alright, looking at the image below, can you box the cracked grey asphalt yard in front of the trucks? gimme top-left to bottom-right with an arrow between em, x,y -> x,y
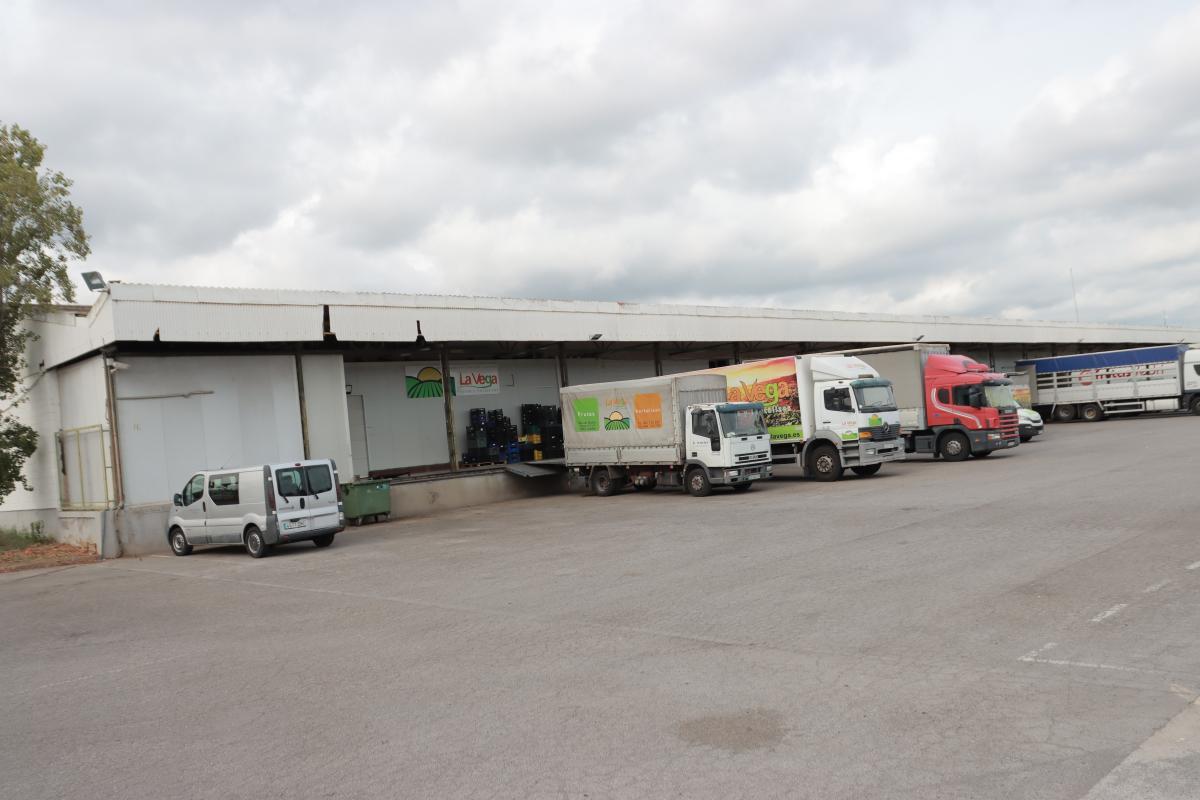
0,416 -> 1200,800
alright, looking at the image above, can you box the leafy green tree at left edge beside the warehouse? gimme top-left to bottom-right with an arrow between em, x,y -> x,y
0,124 -> 91,499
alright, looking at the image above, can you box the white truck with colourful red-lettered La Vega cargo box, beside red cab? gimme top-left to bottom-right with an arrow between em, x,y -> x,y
710,354 -> 905,481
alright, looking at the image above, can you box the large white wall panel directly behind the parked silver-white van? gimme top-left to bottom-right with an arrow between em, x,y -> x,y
115,356 -> 304,505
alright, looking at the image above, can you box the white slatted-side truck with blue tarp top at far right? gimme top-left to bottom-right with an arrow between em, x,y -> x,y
1016,344 -> 1200,422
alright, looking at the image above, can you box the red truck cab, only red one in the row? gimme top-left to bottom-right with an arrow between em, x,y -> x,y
921,354 -> 1020,461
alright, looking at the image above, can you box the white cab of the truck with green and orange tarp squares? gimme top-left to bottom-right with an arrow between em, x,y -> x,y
681,403 -> 772,497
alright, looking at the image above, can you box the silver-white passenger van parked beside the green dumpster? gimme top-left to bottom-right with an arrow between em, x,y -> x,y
167,459 -> 346,558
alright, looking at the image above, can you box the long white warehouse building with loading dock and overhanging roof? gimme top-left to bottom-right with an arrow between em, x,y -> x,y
9,282 -> 1200,557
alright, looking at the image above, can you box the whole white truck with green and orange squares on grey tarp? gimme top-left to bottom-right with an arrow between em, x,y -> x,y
562,373 -> 773,497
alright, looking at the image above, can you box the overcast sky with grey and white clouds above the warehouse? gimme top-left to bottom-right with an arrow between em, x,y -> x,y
0,0 -> 1200,325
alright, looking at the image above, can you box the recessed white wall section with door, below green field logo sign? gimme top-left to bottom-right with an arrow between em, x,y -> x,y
343,361 -> 450,475
